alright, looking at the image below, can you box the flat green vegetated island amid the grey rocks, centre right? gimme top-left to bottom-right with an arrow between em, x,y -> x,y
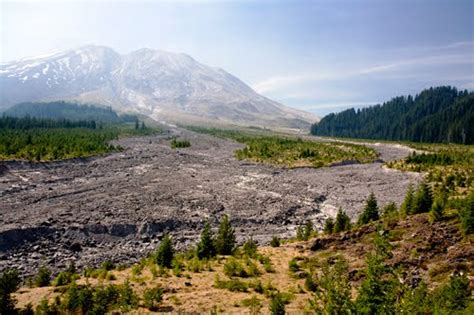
188,127 -> 377,167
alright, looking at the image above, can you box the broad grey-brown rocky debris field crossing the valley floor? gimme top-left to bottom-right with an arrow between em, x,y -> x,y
0,129 -> 420,275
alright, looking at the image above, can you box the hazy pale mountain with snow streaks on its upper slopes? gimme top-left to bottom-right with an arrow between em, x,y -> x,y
0,46 -> 317,128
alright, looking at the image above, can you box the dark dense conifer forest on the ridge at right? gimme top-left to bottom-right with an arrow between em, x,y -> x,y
311,86 -> 474,144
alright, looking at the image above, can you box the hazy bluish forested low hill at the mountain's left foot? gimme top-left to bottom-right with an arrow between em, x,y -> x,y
4,101 -> 138,123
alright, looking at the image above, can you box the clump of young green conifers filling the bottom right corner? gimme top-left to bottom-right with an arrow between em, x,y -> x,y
309,233 -> 472,314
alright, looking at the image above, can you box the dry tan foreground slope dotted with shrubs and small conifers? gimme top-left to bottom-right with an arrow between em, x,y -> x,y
7,214 -> 474,314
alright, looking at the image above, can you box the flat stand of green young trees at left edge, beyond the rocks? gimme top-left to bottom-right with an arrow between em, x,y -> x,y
0,116 -> 157,161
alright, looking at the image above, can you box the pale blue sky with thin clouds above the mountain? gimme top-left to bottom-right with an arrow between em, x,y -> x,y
0,0 -> 474,116
